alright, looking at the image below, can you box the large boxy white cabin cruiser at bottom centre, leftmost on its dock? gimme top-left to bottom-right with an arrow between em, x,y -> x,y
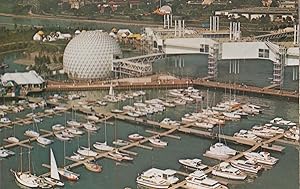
136,168 -> 179,188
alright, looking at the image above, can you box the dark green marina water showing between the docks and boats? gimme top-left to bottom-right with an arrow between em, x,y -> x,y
0,89 -> 298,189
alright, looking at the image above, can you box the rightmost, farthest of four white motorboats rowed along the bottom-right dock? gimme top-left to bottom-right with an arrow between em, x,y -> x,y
244,152 -> 278,165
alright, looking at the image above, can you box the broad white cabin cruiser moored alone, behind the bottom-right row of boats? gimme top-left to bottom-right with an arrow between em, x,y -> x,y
205,142 -> 237,160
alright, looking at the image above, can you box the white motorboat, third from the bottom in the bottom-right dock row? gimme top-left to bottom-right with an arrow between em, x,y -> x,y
230,159 -> 262,174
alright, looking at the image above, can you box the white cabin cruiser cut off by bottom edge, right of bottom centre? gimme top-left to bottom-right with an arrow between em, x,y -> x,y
185,170 -> 228,189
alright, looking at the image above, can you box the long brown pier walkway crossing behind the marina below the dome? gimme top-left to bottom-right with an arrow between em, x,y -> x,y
46,78 -> 299,100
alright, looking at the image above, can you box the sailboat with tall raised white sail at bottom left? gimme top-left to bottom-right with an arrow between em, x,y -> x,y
44,148 -> 64,186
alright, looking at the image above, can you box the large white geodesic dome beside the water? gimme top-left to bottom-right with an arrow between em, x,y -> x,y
63,30 -> 122,79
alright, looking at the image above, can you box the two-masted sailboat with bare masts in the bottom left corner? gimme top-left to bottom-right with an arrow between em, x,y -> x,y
10,148 -> 39,188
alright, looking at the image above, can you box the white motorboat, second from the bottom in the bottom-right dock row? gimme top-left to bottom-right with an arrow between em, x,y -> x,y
212,162 -> 247,180
